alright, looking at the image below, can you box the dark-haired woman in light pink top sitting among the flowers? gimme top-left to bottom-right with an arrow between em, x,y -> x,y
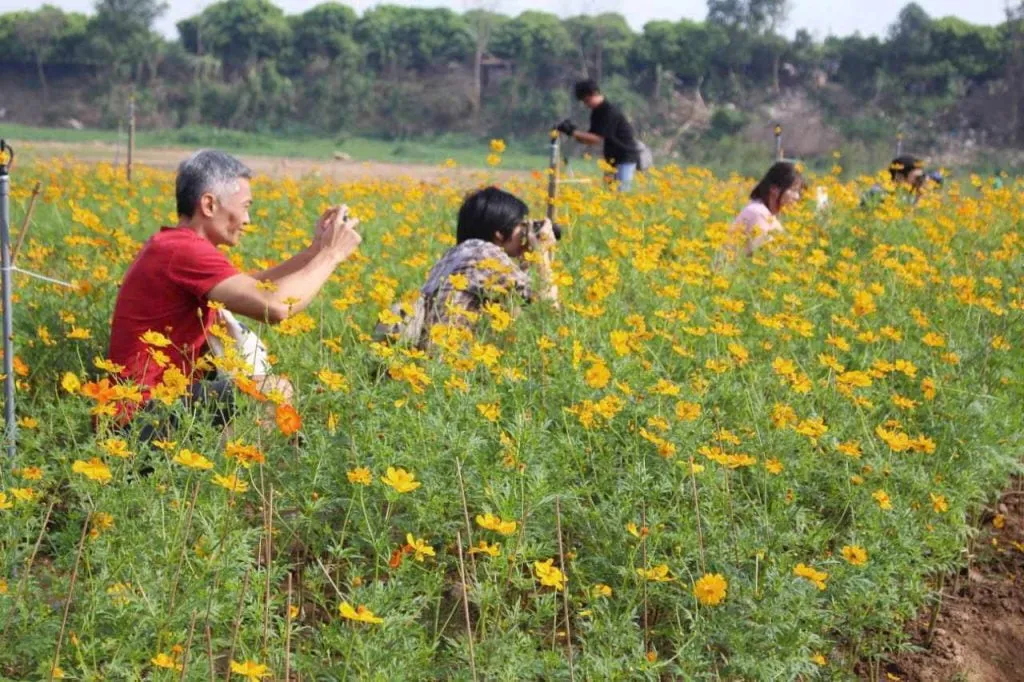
730,161 -> 804,256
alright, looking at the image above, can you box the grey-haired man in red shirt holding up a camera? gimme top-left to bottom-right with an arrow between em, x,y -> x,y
108,150 -> 360,430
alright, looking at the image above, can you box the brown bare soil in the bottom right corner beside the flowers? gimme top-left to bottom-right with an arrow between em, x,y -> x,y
868,480 -> 1024,682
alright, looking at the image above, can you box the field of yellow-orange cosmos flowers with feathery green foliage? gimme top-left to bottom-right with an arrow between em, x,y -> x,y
0,156 -> 1024,680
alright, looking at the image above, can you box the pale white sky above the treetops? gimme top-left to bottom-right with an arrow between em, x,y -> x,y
0,0 -> 1006,38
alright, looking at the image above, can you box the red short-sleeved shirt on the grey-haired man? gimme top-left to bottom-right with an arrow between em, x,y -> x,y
108,227 -> 239,417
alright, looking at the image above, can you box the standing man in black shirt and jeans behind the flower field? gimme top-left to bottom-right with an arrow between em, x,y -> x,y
555,80 -> 640,190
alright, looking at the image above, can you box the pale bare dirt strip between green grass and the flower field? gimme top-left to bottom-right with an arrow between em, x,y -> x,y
17,142 -> 530,184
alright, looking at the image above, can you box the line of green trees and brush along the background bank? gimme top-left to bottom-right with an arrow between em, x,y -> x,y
0,0 -> 1024,148
